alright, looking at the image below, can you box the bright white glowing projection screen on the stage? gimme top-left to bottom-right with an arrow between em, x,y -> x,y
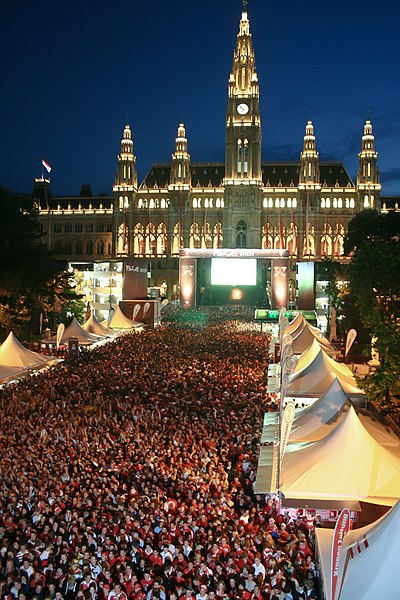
211,258 -> 257,286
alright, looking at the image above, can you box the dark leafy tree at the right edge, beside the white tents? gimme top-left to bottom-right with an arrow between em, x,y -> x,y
345,210 -> 400,400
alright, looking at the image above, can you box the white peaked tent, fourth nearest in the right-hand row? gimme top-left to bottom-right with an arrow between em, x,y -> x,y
286,340 -> 364,399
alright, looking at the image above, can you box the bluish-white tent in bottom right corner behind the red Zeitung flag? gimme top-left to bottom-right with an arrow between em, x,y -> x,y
315,502 -> 400,600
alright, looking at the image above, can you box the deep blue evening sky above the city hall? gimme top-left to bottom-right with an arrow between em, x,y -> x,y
0,0 -> 400,194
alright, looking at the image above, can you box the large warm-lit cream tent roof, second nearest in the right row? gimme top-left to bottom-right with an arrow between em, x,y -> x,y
281,406 -> 400,506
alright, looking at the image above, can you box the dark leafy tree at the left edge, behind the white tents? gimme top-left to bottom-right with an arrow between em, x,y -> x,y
0,187 -> 83,337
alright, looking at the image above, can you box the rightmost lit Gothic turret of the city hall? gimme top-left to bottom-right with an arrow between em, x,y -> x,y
357,119 -> 382,208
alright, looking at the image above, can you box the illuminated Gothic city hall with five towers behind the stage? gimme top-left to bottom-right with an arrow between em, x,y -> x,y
34,2 -> 394,312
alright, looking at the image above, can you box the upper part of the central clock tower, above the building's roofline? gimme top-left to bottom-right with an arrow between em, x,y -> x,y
225,2 -> 261,184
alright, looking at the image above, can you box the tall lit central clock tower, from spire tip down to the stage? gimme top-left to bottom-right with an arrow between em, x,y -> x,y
224,1 -> 262,248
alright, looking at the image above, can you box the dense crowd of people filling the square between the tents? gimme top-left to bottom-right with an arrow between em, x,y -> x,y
0,318 -> 318,600
